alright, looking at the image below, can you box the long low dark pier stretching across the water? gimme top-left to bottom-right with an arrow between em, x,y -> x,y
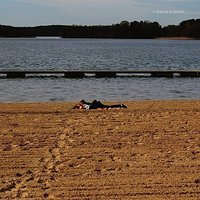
0,70 -> 200,78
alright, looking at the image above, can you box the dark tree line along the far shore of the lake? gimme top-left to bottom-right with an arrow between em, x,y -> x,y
0,19 -> 200,39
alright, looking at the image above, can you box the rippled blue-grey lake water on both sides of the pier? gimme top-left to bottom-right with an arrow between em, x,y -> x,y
0,38 -> 200,102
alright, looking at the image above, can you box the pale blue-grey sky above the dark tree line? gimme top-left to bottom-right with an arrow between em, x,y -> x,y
0,0 -> 200,26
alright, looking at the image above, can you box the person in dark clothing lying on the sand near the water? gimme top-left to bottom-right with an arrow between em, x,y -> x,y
73,100 -> 127,110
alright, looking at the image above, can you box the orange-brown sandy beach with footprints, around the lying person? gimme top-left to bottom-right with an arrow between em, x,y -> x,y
0,101 -> 200,200
